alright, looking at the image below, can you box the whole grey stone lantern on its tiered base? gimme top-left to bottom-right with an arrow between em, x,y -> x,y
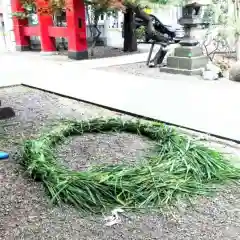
160,0 -> 210,75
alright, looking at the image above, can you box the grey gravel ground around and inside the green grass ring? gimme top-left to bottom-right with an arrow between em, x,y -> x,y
0,87 -> 240,240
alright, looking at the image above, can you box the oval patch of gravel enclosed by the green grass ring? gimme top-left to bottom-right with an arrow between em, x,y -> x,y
57,133 -> 151,170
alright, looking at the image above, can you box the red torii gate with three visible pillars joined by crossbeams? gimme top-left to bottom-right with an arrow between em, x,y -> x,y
11,0 -> 88,60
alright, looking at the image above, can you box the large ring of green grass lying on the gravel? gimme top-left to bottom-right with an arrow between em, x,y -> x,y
21,118 -> 240,212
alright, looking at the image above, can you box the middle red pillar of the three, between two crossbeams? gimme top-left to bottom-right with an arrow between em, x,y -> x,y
36,0 -> 56,52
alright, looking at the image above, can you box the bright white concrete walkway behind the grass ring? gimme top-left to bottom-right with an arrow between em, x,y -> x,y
0,52 -> 240,141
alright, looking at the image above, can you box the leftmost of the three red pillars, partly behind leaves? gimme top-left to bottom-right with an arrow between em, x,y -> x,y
11,0 -> 30,51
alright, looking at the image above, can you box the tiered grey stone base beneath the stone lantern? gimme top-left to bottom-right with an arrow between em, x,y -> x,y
160,46 -> 208,75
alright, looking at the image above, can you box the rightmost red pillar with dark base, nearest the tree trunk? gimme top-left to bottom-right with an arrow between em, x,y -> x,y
66,0 -> 88,60
